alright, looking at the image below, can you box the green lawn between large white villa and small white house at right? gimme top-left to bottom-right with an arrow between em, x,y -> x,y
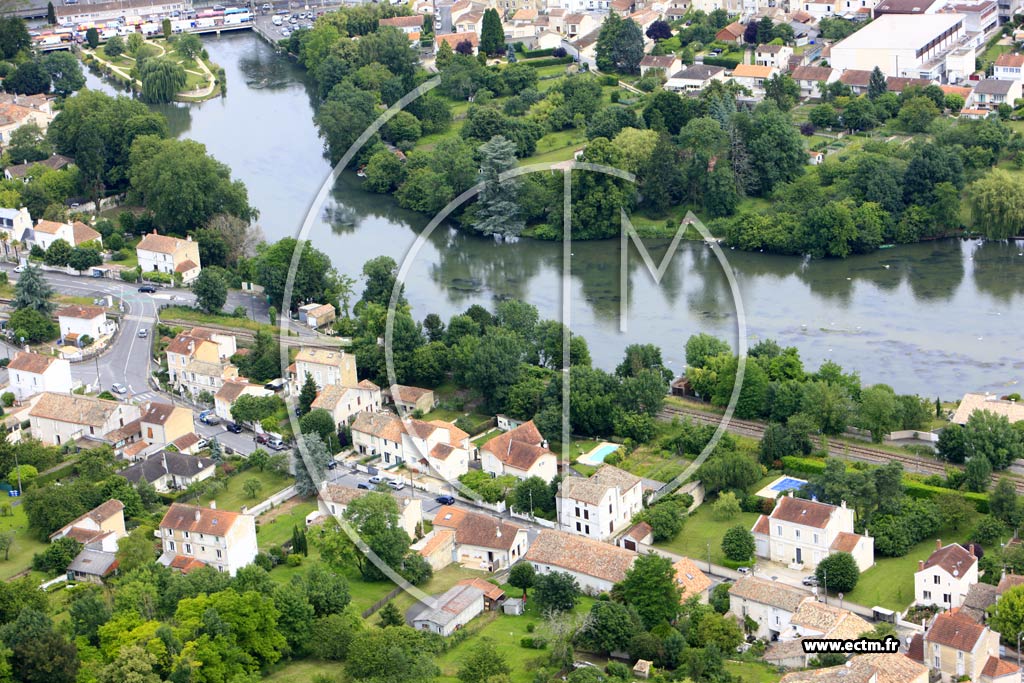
843,516 -> 976,610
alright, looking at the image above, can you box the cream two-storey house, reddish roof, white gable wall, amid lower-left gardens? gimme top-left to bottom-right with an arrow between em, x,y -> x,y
157,503 -> 259,577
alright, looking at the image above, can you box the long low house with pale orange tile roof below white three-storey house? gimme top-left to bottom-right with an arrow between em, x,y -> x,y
524,529 -> 637,595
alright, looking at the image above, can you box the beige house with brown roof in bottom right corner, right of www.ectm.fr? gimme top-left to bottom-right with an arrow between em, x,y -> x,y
908,611 -> 1020,683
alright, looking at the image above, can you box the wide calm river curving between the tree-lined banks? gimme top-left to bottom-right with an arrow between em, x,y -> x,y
83,32 -> 1024,399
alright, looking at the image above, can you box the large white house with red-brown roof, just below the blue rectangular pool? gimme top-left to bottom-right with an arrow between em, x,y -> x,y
751,492 -> 874,571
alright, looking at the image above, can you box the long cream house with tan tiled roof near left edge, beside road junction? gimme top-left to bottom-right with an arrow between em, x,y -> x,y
29,392 -> 139,445
